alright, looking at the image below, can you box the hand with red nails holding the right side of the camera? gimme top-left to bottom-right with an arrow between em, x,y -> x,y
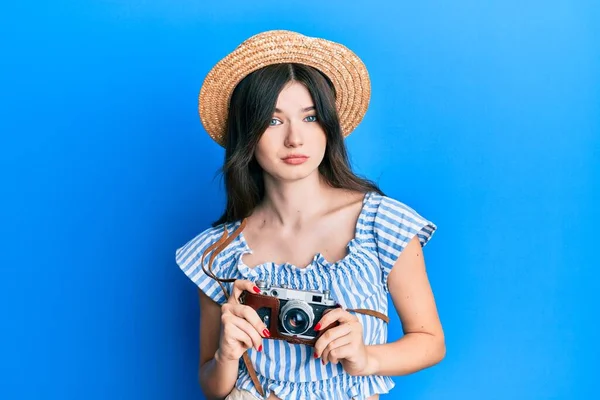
315,308 -> 369,376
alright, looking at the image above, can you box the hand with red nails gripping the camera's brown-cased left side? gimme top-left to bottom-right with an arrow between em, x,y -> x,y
215,280 -> 271,362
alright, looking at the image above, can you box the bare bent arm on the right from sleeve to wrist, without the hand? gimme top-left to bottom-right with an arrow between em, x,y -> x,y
361,236 -> 446,376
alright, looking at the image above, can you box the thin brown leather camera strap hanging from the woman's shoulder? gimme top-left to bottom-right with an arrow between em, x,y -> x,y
200,218 -> 390,396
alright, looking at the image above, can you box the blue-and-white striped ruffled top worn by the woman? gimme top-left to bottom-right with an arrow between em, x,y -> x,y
176,192 -> 436,400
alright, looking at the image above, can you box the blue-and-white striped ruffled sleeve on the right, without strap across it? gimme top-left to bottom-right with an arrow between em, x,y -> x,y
373,197 -> 437,291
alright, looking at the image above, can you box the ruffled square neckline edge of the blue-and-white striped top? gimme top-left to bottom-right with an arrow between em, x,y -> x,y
236,191 -> 374,271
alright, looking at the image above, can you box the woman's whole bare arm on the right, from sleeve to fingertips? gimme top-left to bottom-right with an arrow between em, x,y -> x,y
315,236 -> 446,376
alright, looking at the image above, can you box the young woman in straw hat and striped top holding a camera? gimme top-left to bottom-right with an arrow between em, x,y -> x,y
176,31 -> 445,399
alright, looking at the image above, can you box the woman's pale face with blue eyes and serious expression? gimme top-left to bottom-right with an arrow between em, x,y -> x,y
255,82 -> 326,181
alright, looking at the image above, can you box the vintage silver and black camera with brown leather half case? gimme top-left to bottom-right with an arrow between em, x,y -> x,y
241,281 -> 339,344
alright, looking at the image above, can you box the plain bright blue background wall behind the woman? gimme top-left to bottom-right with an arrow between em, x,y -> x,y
0,0 -> 600,400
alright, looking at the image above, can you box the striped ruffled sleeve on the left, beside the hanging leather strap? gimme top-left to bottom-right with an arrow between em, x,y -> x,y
175,226 -> 231,304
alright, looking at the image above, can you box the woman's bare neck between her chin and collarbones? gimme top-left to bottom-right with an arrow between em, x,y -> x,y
259,173 -> 333,228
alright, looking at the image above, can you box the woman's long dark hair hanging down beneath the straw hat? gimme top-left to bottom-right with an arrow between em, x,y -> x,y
213,63 -> 383,226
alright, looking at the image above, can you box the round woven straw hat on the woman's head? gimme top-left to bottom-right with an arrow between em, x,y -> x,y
198,30 -> 371,146
